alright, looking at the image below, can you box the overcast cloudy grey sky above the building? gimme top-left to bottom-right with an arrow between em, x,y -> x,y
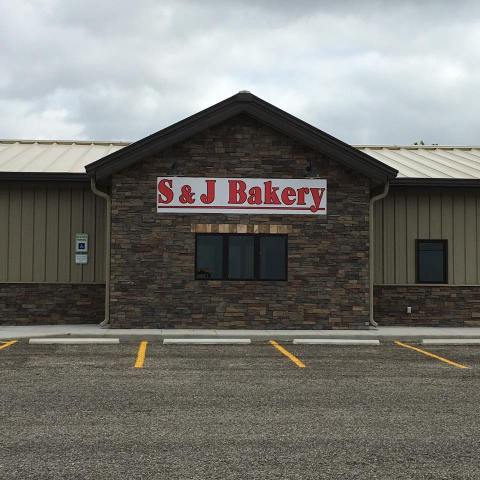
0,0 -> 480,145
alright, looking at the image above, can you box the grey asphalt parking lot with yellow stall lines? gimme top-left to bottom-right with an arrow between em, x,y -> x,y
0,341 -> 480,479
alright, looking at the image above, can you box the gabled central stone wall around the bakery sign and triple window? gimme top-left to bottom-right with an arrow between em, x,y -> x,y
111,115 -> 369,329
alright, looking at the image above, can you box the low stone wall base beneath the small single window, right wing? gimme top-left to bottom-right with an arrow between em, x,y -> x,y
374,285 -> 480,327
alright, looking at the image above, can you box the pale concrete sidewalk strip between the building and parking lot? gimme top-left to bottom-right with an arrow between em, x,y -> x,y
0,325 -> 480,341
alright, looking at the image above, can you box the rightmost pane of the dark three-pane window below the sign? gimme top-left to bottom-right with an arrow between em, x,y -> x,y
259,235 -> 287,280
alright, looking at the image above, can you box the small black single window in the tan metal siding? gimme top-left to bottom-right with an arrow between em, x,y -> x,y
416,240 -> 448,283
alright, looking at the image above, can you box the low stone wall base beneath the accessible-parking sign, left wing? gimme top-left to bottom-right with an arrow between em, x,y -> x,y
0,283 -> 105,325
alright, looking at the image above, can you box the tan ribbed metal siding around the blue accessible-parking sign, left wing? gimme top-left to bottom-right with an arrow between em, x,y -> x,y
0,182 -> 105,283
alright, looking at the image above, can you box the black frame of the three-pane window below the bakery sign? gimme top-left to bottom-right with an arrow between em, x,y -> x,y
193,232 -> 288,282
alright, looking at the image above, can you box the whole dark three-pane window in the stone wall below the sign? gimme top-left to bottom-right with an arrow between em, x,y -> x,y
195,233 -> 288,280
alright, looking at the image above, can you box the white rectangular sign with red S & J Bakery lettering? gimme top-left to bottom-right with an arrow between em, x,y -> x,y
157,177 -> 327,215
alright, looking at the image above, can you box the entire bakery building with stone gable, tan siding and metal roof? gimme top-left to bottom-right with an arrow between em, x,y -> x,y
0,92 -> 480,329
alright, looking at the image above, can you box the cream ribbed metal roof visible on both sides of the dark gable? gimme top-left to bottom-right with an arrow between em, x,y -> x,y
0,140 -> 480,179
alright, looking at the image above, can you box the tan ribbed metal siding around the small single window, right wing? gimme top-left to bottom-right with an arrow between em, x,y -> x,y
374,189 -> 480,285
